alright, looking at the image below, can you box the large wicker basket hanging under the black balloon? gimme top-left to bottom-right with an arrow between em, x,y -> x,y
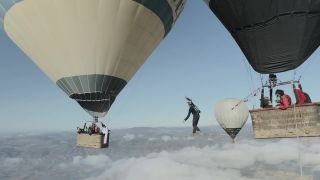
250,103 -> 320,138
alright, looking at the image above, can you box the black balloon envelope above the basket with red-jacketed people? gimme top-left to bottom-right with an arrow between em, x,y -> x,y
209,0 -> 320,73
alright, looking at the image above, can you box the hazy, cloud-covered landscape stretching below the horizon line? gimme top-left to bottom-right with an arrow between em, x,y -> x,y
0,126 -> 320,180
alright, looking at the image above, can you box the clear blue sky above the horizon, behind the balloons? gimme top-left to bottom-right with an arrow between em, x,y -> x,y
0,1 -> 320,131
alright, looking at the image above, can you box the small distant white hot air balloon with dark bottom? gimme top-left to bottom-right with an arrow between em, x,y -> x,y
214,98 -> 249,142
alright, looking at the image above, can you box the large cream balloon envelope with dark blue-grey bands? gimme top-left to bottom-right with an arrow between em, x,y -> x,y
0,0 -> 185,117
